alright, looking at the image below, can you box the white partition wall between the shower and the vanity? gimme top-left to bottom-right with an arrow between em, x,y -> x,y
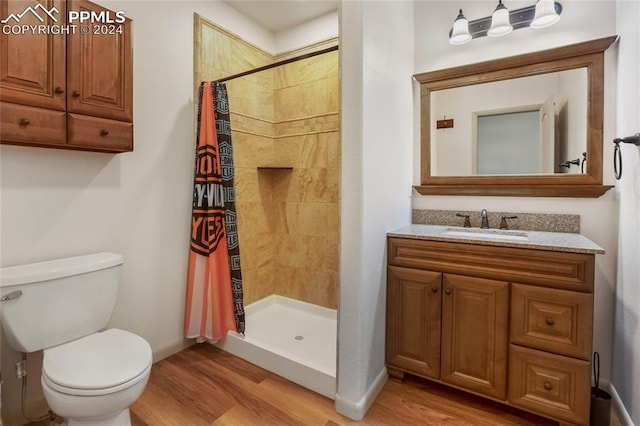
336,0 -> 413,419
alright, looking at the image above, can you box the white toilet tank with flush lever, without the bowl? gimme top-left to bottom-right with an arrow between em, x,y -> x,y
0,253 -> 122,352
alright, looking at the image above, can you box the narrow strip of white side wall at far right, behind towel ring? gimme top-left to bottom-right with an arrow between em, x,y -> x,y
612,1 -> 640,425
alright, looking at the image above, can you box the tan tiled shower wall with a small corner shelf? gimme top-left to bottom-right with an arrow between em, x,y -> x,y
195,19 -> 340,309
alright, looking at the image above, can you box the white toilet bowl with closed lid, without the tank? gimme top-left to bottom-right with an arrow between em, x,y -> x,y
41,328 -> 152,426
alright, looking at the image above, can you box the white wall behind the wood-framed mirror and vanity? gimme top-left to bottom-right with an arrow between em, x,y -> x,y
413,0 -> 624,390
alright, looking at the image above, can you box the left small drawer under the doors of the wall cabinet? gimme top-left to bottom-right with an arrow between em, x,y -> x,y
0,102 -> 67,145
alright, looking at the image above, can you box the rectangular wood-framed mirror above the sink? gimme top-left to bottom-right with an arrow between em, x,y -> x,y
414,36 -> 617,198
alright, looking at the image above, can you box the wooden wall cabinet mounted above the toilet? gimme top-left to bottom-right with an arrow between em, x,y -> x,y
0,0 -> 133,152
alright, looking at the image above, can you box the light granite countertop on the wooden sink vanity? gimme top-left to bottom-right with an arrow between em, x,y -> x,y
387,224 -> 604,254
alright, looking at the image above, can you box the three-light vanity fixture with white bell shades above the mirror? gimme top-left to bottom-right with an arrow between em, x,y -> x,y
449,0 -> 562,45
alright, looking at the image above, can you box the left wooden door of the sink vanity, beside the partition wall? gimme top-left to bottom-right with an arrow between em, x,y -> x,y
386,266 -> 442,379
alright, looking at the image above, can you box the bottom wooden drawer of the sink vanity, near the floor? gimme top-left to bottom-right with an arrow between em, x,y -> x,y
509,345 -> 591,425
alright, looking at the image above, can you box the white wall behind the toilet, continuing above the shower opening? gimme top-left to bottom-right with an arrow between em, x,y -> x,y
0,1 -> 273,420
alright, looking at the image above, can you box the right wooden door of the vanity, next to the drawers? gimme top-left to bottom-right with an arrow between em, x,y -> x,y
441,274 -> 509,400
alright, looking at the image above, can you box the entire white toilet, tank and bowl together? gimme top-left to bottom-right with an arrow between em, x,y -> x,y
0,253 -> 152,426
